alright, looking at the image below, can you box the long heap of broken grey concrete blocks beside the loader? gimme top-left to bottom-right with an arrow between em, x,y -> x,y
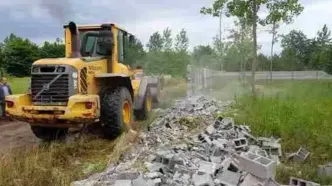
74,96 -> 320,186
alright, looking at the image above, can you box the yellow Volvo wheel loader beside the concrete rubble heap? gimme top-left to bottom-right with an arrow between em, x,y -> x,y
6,22 -> 159,140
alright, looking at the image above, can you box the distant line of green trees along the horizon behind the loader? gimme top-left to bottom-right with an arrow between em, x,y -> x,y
0,23 -> 332,76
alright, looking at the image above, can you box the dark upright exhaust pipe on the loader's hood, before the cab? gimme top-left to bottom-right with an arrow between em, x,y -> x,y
68,21 -> 81,58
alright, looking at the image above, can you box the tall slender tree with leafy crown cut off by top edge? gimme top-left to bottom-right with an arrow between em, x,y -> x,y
201,0 -> 303,95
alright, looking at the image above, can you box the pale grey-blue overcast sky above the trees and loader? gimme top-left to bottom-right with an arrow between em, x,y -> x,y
0,0 -> 332,54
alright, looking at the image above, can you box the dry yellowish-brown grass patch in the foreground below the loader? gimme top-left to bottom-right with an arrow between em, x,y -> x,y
0,136 -> 117,186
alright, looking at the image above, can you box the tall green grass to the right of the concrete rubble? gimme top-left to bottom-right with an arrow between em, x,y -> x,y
227,81 -> 332,184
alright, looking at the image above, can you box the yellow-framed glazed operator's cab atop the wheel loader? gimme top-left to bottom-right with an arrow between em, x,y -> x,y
64,22 -> 135,64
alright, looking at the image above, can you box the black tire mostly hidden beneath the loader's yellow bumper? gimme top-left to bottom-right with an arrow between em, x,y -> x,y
30,126 -> 68,141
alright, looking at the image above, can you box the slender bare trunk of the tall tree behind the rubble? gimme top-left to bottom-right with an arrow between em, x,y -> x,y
251,0 -> 257,97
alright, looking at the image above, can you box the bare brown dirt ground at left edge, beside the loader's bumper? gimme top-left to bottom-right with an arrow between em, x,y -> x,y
0,120 -> 36,152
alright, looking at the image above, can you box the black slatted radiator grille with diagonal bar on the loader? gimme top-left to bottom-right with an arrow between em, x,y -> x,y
31,74 -> 69,105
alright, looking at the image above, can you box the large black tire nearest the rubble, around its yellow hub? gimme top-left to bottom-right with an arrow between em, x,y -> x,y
100,87 -> 133,139
